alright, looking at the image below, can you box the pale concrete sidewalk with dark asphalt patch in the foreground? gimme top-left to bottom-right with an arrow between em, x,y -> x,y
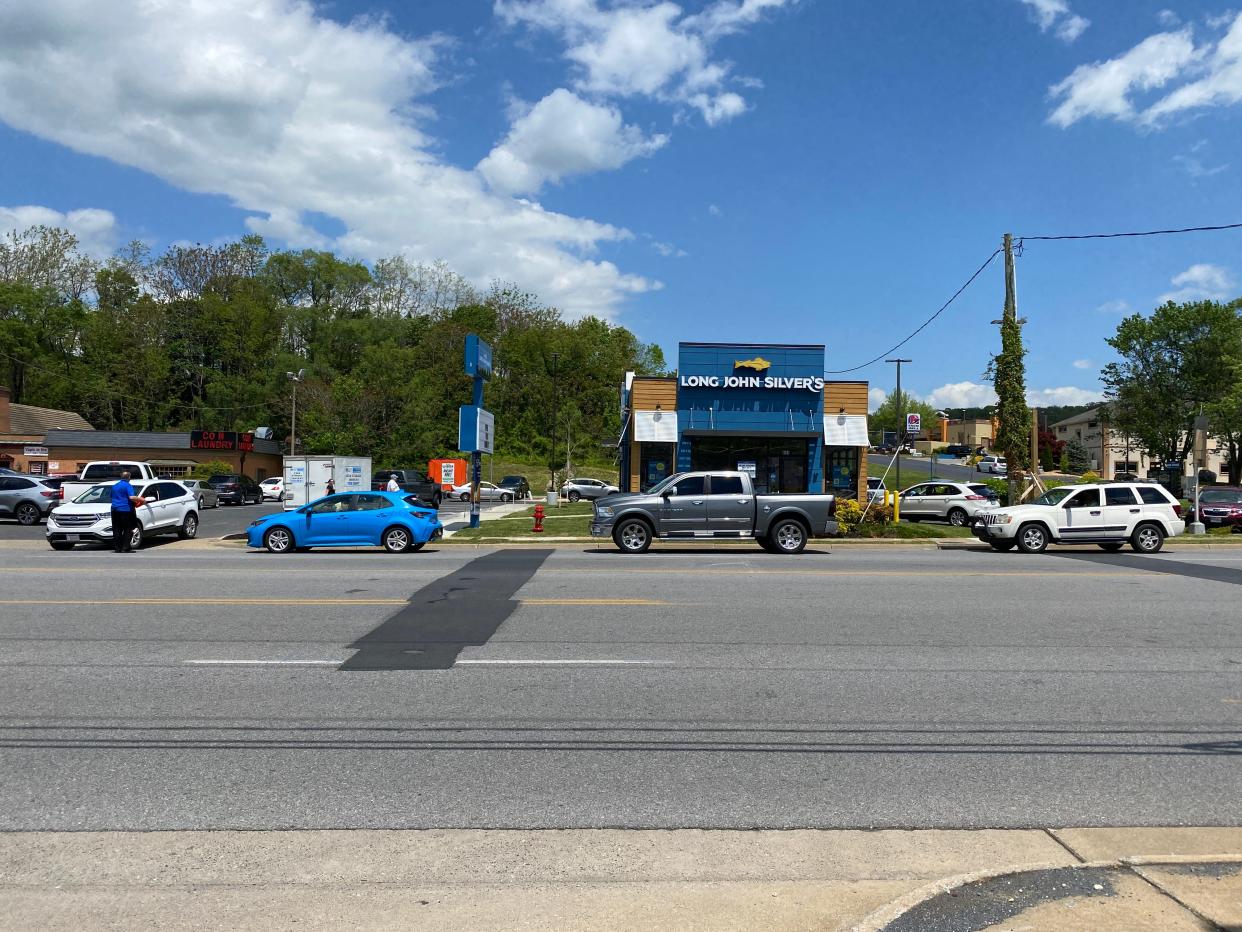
0,828 -> 1242,932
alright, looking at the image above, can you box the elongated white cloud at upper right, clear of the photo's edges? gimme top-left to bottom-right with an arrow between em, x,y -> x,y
1048,29 -> 1199,127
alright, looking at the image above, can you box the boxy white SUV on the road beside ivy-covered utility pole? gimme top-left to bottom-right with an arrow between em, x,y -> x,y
974,482 -> 1186,553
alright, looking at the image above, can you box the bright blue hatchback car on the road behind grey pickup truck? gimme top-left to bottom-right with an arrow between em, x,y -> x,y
246,492 -> 443,553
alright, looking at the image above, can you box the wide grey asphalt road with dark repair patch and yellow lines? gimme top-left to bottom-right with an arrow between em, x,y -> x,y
0,536 -> 1242,830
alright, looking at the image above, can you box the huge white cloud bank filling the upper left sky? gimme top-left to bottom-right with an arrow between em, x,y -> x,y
0,0 -> 658,316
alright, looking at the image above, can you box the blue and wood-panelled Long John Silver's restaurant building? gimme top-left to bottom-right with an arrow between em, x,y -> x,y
620,343 -> 867,498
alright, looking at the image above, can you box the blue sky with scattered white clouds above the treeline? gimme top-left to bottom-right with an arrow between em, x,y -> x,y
0,0 -> 1242,406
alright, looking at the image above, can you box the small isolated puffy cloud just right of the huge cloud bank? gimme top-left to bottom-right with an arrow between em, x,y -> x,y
478,87 -> 668,194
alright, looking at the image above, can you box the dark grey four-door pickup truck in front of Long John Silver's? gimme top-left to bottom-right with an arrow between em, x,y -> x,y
591,472 -> 838,553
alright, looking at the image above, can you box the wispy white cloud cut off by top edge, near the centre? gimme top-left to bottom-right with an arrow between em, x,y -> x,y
496,0 -> 792,124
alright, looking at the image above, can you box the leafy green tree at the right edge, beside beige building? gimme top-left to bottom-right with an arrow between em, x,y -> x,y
1100,301 -> 1242,461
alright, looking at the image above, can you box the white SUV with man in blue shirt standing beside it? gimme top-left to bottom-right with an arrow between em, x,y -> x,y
46,480 -> 199,551
